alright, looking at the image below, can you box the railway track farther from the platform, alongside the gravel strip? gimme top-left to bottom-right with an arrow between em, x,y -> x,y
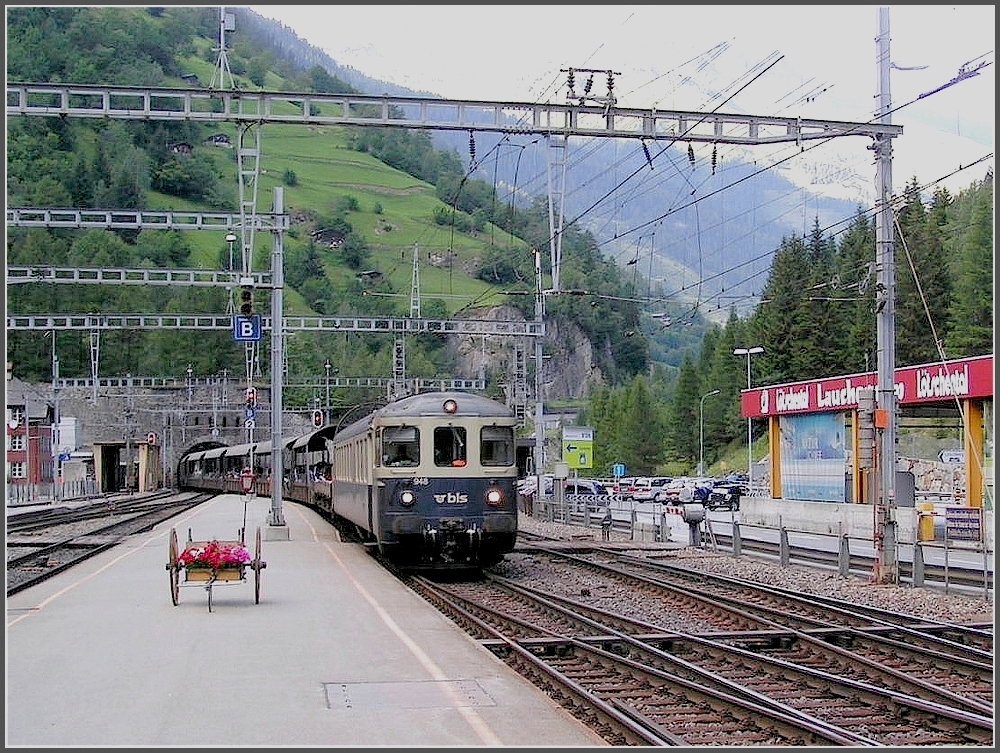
504,552 -> 993,713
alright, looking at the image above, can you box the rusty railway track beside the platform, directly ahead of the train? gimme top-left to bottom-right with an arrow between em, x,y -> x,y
409,577 -> 993,745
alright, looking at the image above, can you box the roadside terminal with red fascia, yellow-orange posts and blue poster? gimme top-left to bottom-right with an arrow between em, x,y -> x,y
741,354 -> 994,509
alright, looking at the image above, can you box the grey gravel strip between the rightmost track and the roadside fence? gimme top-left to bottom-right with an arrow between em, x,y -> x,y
518,513 -> 995,624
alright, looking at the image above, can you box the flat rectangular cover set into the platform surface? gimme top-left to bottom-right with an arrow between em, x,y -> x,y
323,680 -> 496,709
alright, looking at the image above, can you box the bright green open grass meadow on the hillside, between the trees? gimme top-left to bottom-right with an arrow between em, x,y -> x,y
149,45 -> 530,315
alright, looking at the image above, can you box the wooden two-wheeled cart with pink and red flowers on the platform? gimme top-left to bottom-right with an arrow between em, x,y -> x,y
167,526 -> 267,612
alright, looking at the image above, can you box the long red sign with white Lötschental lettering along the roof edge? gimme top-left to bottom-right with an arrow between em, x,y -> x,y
740,355 -> 993,418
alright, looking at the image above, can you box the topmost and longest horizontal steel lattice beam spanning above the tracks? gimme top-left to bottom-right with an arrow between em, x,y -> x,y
7,82 -> 903,146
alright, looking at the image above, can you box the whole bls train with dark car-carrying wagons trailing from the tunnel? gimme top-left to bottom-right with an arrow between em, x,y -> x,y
177,391 -> 520,569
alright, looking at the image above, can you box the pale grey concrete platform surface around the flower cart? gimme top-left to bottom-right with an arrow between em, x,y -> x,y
5,495 -> 606,748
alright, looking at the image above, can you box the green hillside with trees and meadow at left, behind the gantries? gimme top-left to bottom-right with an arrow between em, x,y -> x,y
7,8 -> 648,396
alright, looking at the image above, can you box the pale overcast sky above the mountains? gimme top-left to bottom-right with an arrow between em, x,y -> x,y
248,4 -> 996,197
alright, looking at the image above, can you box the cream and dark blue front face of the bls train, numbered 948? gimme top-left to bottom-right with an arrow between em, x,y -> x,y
377,396 -> 517,567
